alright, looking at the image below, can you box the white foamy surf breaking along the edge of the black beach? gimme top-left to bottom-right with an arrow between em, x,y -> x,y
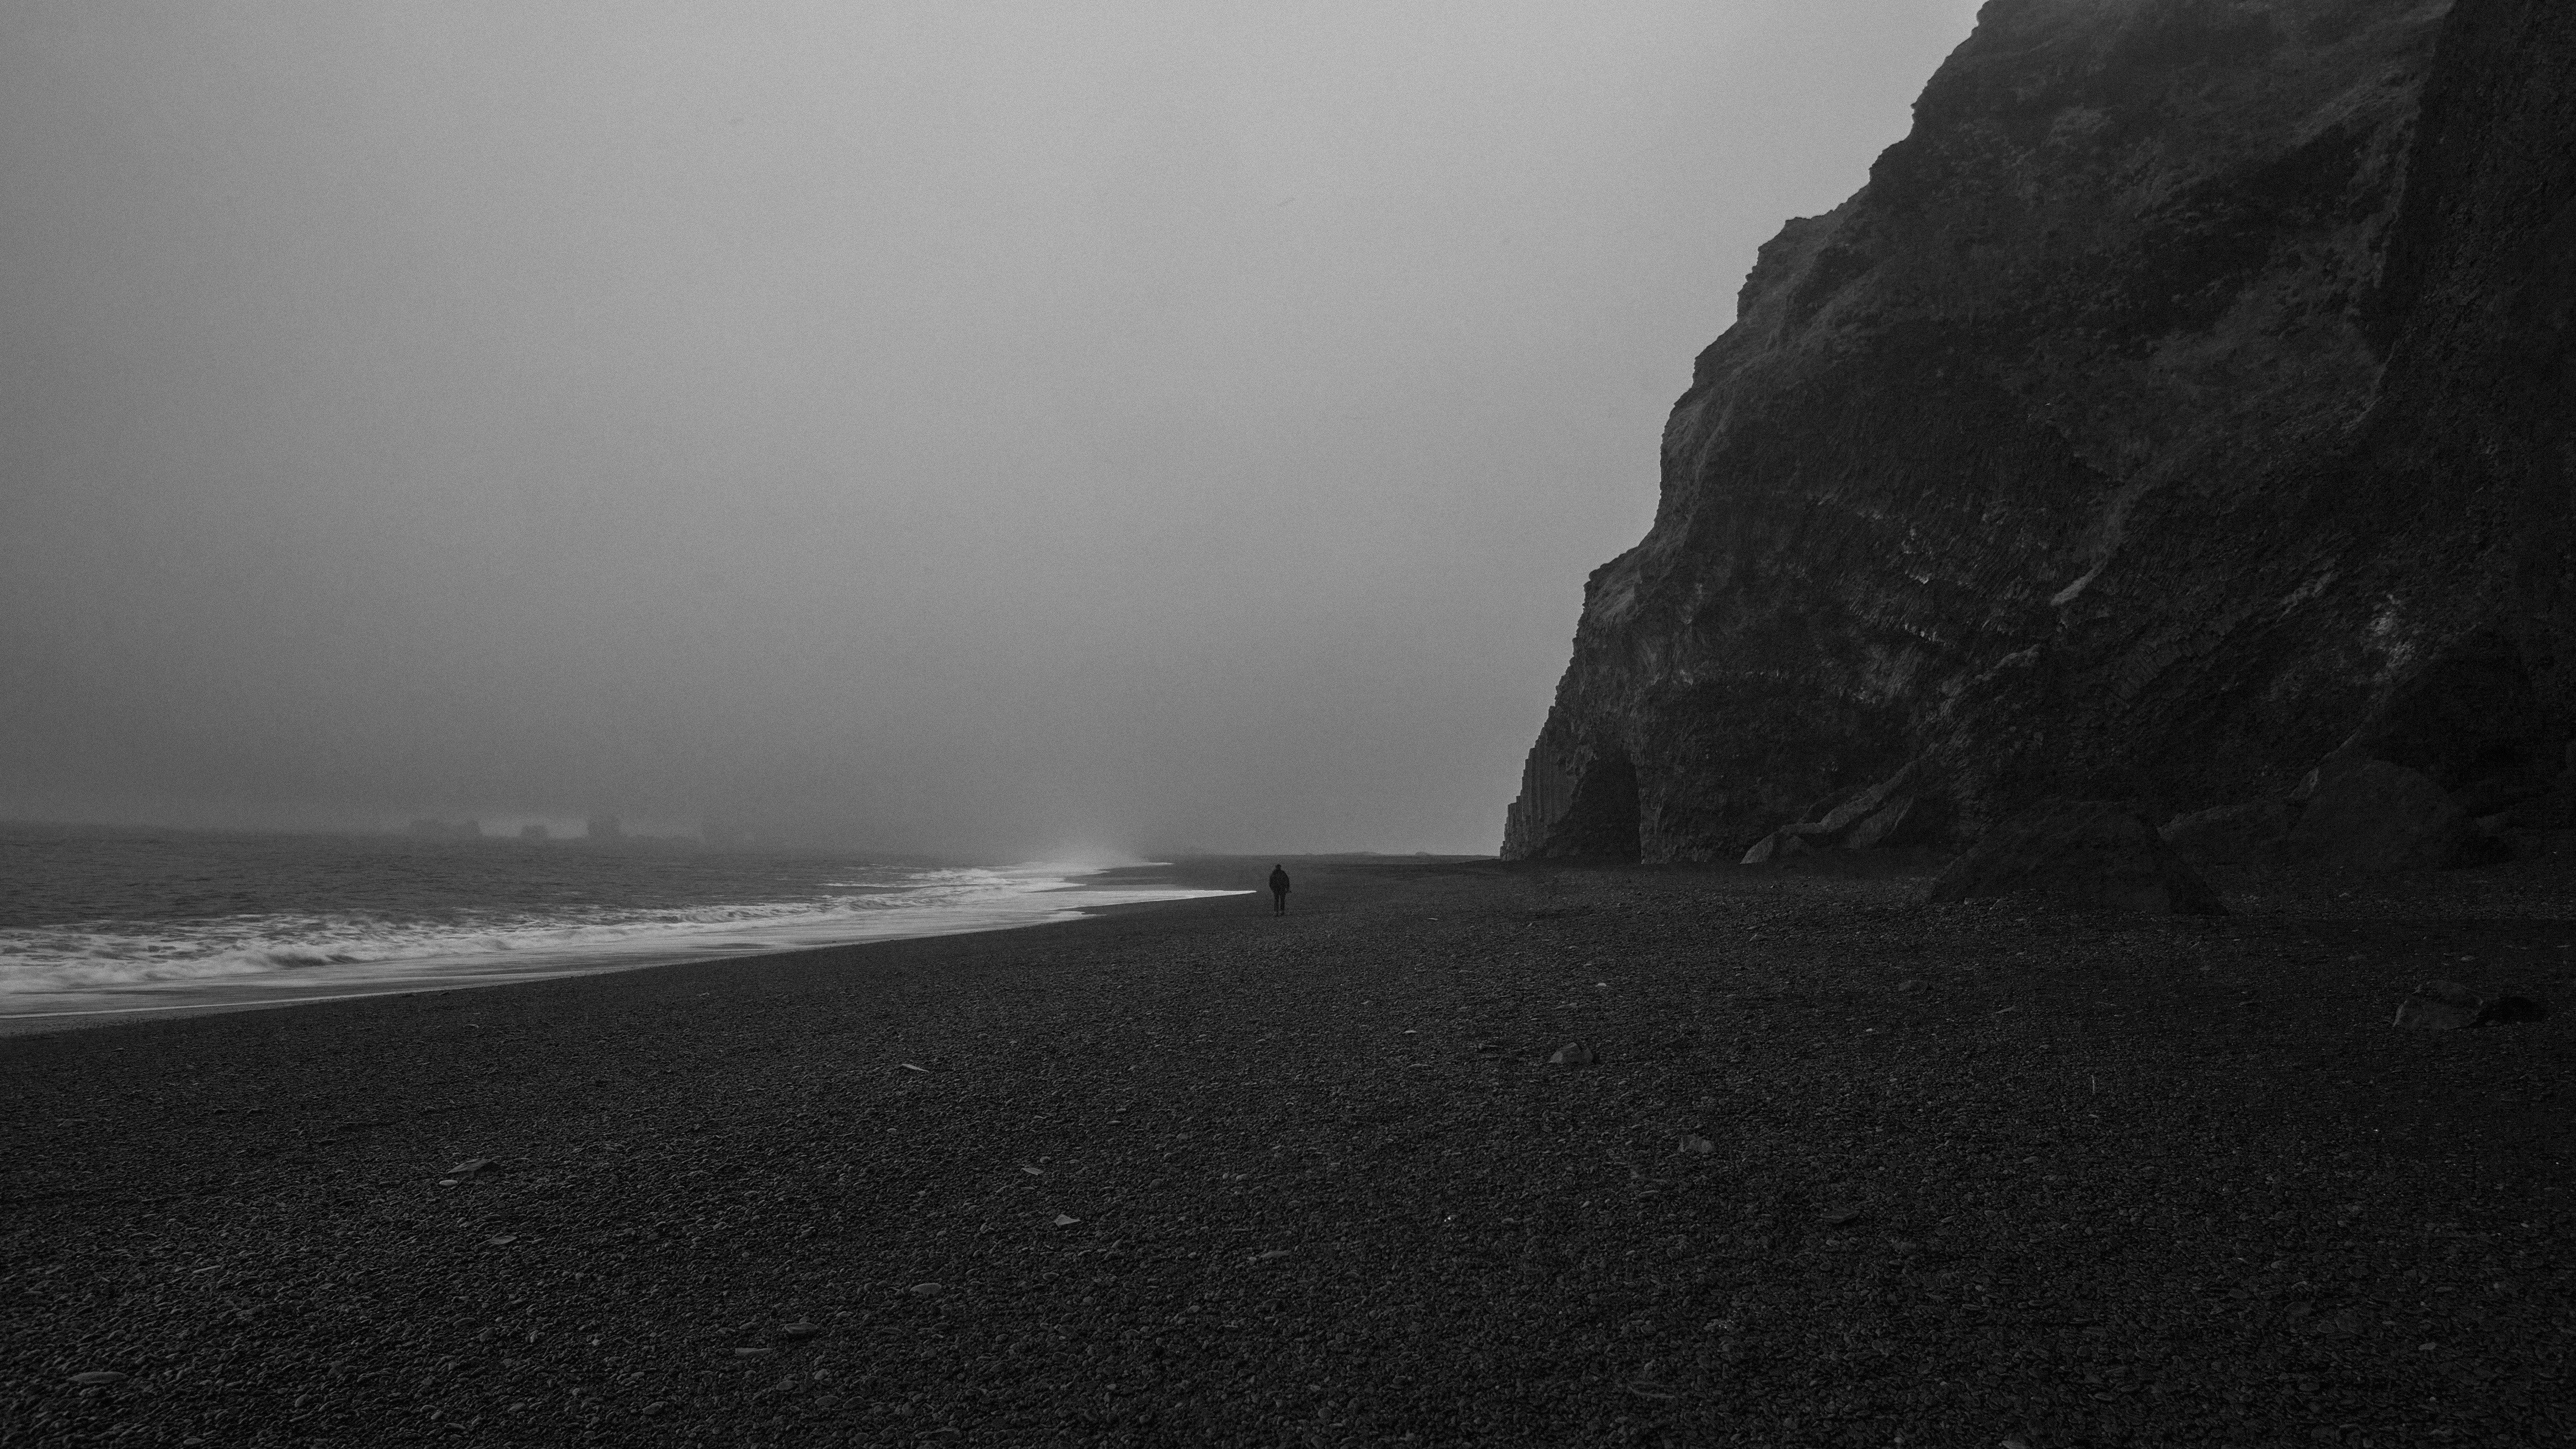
0,862 -> 1211,1004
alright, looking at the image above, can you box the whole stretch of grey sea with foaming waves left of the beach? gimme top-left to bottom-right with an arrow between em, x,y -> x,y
0,826 -> 1236,1022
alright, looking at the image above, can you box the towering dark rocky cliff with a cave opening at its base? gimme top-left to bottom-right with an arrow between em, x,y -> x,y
1504,0 -> 2576,860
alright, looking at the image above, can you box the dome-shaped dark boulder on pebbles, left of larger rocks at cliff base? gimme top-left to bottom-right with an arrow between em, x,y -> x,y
1927,801 -> 2225,916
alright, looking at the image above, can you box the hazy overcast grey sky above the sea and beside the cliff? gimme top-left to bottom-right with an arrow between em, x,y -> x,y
0,0 -> 1973,857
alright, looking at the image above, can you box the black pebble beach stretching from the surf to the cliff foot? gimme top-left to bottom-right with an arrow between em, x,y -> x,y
0,860 -> 2576,1449
